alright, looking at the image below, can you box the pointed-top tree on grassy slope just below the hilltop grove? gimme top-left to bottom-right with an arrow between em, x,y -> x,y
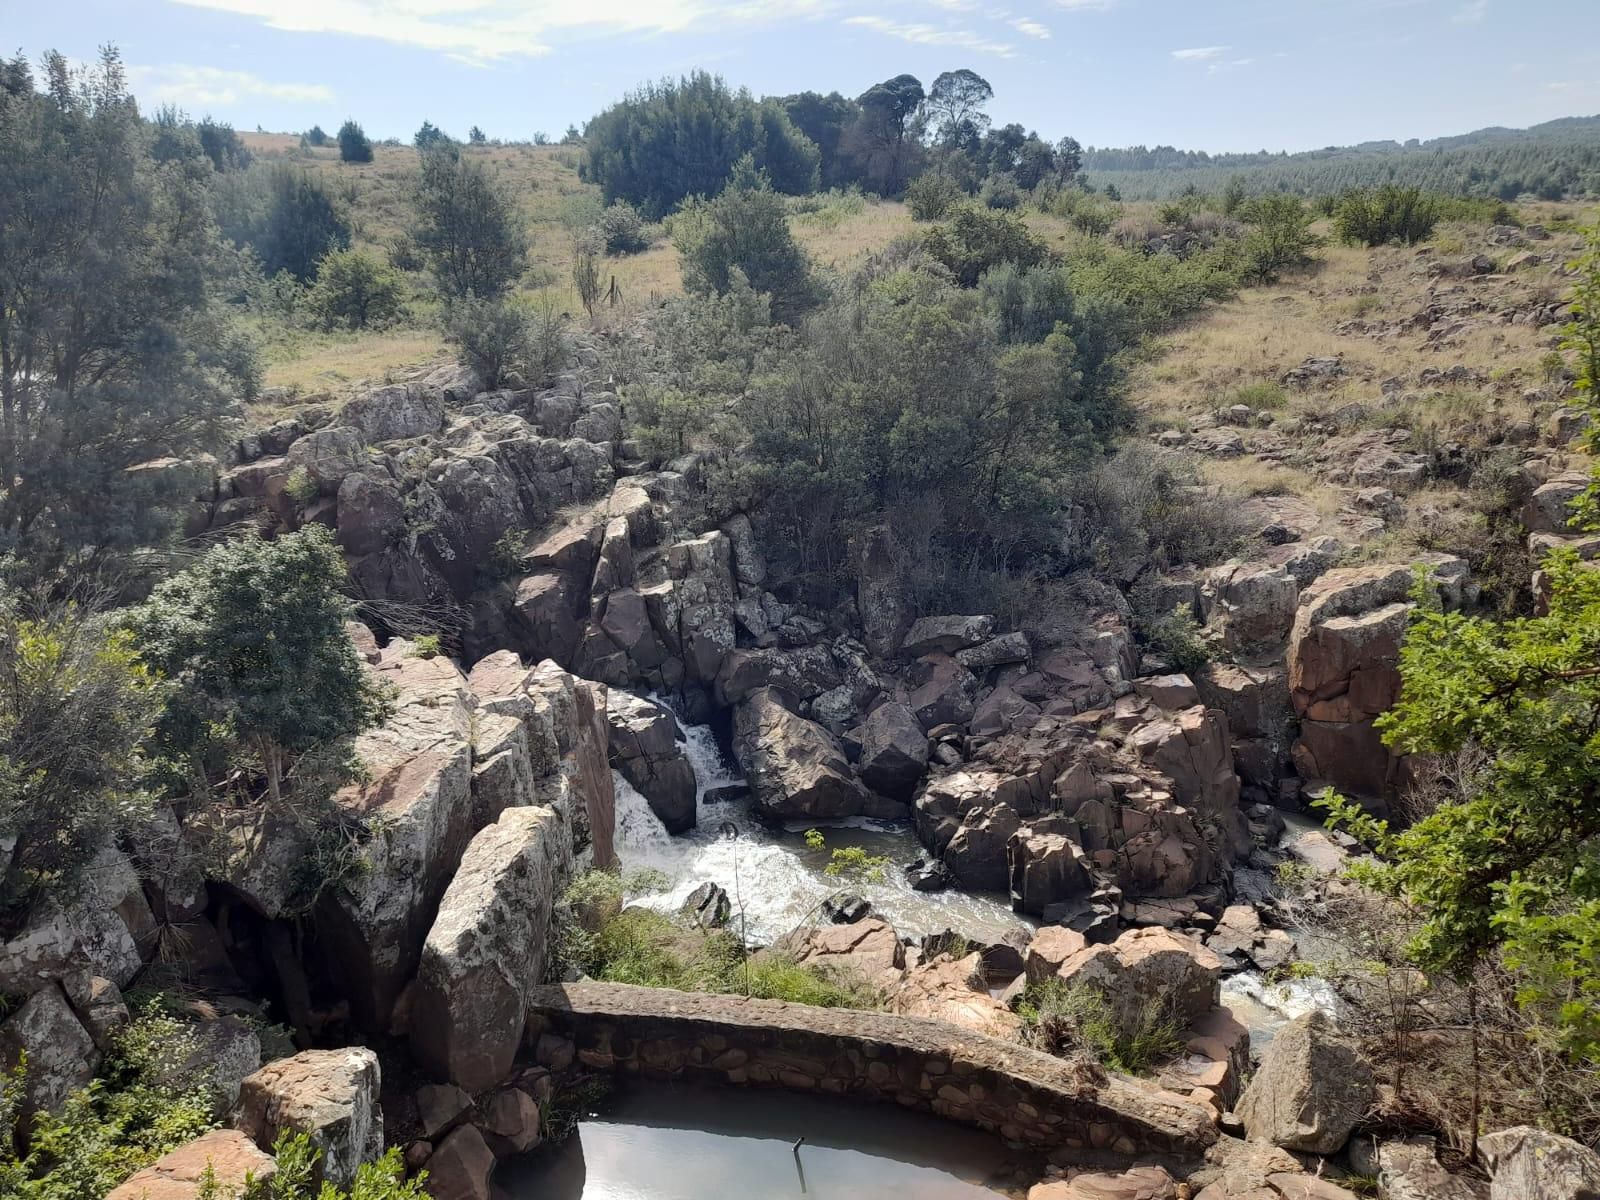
672,158 -> 816,322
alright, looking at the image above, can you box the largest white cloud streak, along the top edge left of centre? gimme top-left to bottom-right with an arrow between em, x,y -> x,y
173,0 -> 835,66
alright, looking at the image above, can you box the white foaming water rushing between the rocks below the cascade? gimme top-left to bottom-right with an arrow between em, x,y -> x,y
613,698 -> 1024,944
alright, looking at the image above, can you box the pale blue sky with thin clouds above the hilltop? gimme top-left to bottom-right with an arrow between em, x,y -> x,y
12,0 -> 1600,150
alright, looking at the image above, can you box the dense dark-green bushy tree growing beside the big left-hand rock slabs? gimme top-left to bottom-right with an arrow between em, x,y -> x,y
128,525 -> 389,806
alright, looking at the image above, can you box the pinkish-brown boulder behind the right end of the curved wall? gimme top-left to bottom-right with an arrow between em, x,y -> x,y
1056,926 -> 1222,1030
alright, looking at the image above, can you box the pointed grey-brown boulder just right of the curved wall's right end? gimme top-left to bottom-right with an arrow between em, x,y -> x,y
1238,1010 -> 1374,1154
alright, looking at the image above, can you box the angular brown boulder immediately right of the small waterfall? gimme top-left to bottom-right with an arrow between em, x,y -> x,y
733,688 -> 866,821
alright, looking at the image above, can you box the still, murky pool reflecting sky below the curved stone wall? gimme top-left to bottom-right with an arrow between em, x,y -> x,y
494,1083 -> 1037,1200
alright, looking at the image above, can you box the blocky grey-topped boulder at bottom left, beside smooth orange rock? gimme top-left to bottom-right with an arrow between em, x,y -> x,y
234,1046 -> 384,1187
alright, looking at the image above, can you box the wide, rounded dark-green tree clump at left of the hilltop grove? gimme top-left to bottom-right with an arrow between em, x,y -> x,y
584,72 -> 819,218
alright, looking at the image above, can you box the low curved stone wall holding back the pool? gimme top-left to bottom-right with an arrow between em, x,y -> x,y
528,982 -> 1216,1163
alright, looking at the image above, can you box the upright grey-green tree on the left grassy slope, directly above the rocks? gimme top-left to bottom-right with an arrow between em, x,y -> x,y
416,144 -> 528,299
